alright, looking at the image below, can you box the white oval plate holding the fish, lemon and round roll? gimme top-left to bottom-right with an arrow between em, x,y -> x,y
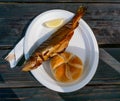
24,9 -> 99,92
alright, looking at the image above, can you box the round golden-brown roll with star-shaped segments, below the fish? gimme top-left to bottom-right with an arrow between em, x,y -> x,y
50,52 -> 83,83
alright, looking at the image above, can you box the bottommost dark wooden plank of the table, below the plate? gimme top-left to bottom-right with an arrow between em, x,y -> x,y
0,85 -> 120,101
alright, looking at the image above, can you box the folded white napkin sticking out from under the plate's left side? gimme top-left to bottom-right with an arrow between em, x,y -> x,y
5,37 -> 24,68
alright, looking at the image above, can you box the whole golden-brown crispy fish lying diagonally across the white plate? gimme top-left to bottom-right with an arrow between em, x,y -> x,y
22,7 -> 86,71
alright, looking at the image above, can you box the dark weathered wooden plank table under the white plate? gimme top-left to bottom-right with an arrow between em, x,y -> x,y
0,0 -> 120,101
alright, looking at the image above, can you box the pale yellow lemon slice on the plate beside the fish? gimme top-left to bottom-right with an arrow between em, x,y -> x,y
44,18 -> 63,28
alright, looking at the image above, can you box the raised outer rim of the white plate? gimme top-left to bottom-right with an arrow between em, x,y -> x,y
24,9 -> 99,93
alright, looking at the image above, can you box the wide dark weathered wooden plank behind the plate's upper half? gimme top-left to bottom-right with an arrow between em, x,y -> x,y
0,3 -> 120,47
